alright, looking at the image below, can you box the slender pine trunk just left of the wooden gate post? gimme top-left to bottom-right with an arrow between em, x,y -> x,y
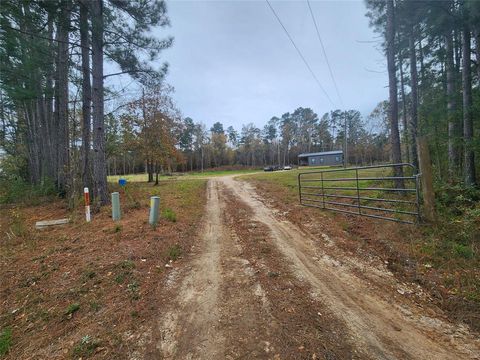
408,25 -> 418,170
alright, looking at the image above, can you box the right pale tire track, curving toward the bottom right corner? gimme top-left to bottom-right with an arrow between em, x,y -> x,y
224,177 -> 480,359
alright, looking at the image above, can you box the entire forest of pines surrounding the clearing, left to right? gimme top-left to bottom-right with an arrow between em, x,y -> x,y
0,0 -> 480,205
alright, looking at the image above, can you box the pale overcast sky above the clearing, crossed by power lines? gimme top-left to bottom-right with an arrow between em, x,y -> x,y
114,1 -> 388,129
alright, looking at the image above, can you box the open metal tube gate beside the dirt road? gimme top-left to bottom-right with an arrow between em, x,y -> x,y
298,163 -> 420,224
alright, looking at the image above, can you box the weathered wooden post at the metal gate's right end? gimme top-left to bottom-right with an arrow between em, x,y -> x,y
417,136 -> 436,222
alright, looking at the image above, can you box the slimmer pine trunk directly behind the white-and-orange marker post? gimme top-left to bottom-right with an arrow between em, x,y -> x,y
80,2 -> 92,188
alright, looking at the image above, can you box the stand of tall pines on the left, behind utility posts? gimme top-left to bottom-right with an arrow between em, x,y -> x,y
0,0 -> 173,205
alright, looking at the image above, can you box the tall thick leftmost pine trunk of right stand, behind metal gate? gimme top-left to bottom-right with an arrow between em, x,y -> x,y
385,0 -> 404,188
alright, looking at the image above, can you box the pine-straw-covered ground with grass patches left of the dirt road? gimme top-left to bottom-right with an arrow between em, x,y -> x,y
0,179 -> 206,359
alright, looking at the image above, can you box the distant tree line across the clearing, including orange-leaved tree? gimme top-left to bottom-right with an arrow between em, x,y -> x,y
107,102 -> 390,181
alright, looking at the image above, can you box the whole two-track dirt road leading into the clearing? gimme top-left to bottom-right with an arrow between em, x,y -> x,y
154,177 -> 480,359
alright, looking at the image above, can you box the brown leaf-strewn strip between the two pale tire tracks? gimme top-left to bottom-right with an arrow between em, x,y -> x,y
222,189 -> 360,360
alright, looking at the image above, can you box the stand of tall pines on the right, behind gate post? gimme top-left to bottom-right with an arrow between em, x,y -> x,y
366,0 -> 480,187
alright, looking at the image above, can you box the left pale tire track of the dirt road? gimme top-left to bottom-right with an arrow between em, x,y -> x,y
157,182 -> 224,359
